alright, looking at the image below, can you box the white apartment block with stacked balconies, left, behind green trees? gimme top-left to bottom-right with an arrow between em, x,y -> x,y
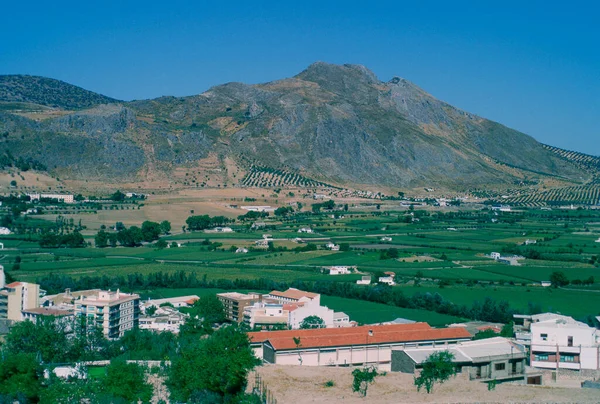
75,290 -> 140,339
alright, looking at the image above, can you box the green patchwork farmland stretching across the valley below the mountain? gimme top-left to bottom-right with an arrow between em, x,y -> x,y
0,196 -> 600,324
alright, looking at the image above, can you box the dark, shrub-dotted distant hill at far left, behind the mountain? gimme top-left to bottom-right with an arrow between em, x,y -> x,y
0,75 -> 117,110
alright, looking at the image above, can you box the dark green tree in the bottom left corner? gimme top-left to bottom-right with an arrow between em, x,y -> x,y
0,353 -> 44,403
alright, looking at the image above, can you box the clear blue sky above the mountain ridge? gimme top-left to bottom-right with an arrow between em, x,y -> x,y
0,0 -> 600,155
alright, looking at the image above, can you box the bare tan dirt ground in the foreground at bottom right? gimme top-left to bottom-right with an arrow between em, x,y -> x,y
256,365 -> 600,404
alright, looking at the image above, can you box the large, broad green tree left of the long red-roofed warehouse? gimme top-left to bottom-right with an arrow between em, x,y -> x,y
167,326 -> 259,402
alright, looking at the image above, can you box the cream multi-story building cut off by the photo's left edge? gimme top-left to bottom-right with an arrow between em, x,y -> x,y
0,280 -> 40,321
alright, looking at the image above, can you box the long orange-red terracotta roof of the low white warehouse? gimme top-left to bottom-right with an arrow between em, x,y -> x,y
248,323 -> 471,350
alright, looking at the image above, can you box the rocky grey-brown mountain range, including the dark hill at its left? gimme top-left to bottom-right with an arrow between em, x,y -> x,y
0,62 -> 589,189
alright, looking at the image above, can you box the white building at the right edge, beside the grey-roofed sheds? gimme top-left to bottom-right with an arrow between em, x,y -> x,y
526,313 -> 600,370
